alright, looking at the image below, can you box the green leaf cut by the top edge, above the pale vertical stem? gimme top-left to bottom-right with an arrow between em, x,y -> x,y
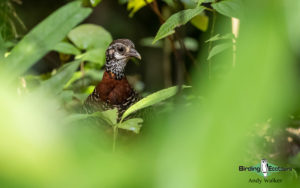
212,0 -> 242,18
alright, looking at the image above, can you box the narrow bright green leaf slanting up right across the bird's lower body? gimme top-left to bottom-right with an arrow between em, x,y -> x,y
121,86 -> 190,122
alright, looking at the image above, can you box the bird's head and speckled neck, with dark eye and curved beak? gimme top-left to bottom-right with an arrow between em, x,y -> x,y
105,39 -> 141,79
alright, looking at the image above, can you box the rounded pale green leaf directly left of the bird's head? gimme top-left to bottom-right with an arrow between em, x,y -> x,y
68,24 -> 112,50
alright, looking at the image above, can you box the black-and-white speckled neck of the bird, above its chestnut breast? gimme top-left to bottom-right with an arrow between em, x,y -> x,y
105,59 -> 127,80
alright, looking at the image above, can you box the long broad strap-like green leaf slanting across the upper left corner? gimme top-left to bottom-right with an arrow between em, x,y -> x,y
0,1 -> 91,81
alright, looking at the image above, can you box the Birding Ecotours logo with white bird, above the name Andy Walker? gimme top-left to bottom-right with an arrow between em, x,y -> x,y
239,159 -> 293,178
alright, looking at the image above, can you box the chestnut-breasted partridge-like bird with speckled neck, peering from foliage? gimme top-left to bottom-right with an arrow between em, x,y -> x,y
83,39 -> 141,121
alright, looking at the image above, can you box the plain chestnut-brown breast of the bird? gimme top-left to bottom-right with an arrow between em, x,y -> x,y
96,71 -> 133,105
